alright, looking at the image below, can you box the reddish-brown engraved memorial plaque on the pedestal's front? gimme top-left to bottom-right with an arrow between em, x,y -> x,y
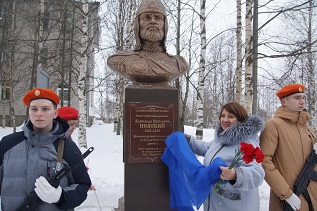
127,103 -> 177,163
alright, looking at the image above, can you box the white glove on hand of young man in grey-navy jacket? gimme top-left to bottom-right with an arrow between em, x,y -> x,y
34,176 -> 62,204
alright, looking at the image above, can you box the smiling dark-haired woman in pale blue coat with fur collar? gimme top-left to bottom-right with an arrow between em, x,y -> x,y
186,102 -> 264,211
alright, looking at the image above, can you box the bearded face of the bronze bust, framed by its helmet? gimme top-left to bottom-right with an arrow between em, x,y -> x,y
139,13 -> 164,43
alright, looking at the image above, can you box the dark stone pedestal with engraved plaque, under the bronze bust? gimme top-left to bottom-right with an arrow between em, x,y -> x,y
123,85 -> 179,211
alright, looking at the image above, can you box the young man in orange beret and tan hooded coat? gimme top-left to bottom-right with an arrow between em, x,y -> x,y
260,84 -> 317,211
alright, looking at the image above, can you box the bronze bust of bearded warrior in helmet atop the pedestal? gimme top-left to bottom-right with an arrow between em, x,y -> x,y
107,0 -> 189,85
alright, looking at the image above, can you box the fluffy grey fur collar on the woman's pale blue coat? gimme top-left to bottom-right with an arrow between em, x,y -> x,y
215,115 -> 264,145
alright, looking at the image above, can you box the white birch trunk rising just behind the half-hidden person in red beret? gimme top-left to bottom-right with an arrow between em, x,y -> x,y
78,0 -> 88,148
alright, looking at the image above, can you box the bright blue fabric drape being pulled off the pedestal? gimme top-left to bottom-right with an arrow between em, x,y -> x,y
161,132 -> 227,211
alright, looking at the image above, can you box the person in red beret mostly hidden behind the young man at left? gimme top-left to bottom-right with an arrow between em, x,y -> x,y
58,106 -> 96,190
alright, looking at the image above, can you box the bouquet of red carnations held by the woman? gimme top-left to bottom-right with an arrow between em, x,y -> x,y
214,142 -> 264,206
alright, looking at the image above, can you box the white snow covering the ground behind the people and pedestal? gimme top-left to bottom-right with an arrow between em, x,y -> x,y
0,123 -> 269,211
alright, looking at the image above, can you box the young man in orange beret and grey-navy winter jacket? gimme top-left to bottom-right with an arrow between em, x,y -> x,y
0,88 -> 91,211
